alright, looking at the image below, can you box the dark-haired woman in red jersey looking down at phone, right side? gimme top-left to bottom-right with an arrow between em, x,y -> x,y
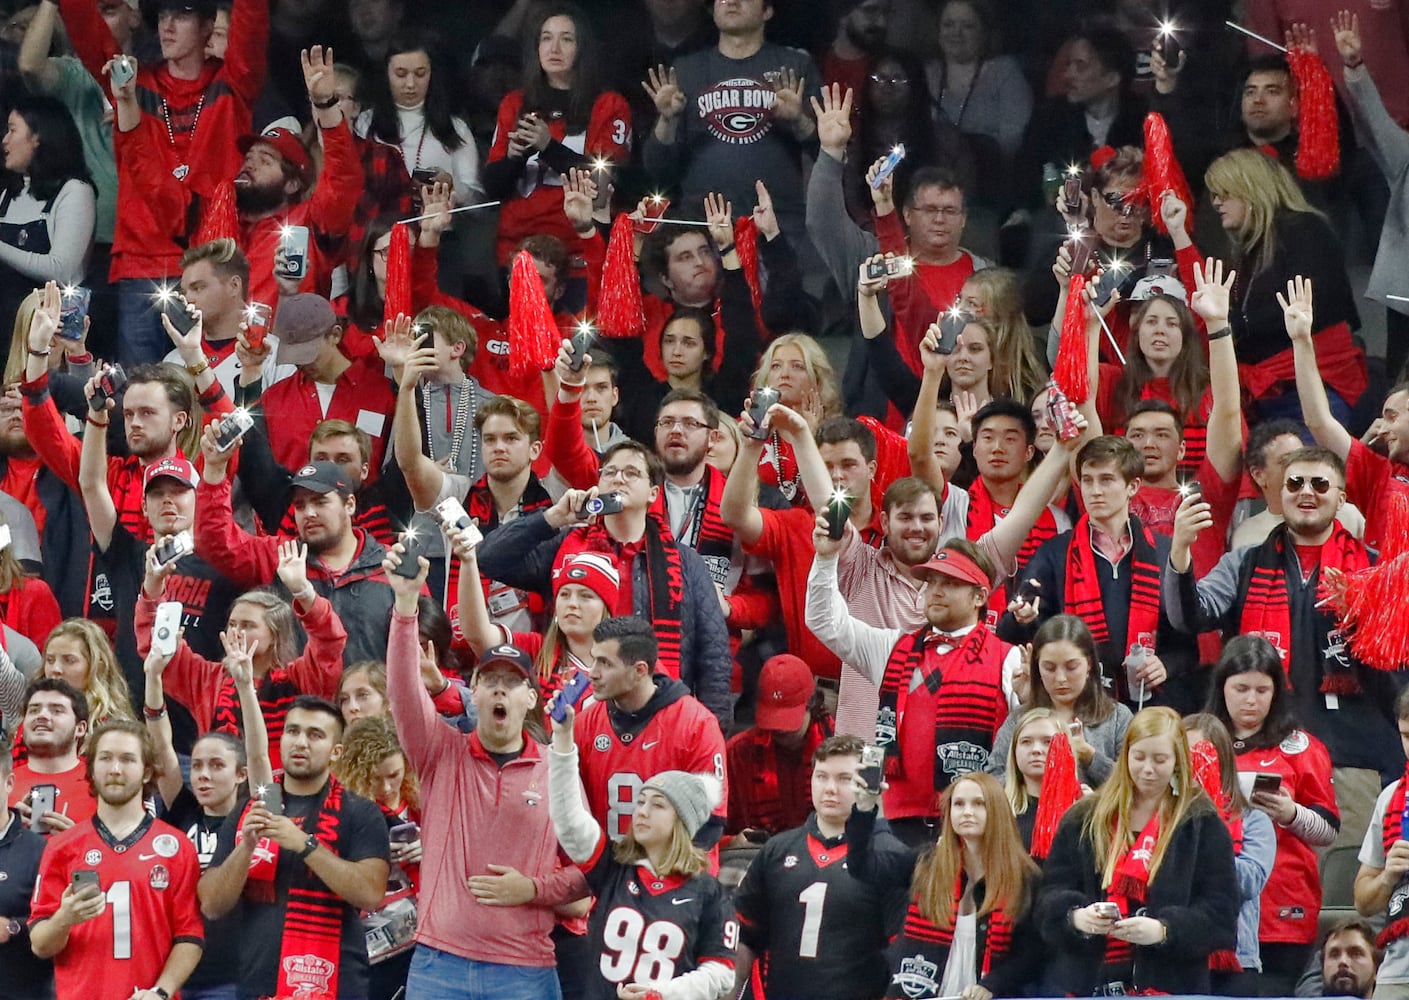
1206,635 -> 1340,996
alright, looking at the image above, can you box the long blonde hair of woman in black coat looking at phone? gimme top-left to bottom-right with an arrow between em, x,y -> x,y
1082,707 -> 1208,886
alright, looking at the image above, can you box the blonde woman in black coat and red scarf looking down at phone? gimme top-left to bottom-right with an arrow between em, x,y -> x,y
1037,708 -> 1239,996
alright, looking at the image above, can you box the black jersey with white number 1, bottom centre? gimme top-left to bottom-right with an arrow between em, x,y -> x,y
734,815 -> 898,1000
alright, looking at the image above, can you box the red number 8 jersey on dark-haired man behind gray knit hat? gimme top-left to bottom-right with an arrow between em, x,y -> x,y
575,675 -> 728,839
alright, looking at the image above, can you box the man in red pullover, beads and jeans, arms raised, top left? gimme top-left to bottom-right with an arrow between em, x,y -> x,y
59,0 -> 269,363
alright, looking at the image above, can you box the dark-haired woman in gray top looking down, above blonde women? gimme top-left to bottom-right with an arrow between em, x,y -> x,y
988,614 -> 1131,787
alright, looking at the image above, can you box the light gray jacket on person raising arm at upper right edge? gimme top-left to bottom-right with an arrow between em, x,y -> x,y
1344,65 -> 1409,313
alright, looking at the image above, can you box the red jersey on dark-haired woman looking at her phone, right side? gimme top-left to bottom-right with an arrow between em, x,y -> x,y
1237,730 -> 1340,945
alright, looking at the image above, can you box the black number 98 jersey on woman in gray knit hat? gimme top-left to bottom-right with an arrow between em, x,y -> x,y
581,835 -> 738,1000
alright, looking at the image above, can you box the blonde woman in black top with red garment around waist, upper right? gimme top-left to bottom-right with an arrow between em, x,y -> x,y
1200,149 -> 1365,424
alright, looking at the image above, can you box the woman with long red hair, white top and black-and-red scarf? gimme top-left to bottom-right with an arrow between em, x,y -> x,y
847,772 -> 1041,1000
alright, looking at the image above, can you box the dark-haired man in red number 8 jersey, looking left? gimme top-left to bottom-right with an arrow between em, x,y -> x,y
573,615 -> 728,848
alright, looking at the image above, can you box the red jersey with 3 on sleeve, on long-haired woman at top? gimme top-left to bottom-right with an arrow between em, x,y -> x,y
486,90 -> 631,266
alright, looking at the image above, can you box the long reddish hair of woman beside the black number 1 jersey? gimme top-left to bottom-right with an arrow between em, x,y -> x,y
910,770 -> 1037,928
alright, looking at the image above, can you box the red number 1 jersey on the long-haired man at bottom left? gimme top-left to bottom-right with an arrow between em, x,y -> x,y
30,817 -> 206,1000
